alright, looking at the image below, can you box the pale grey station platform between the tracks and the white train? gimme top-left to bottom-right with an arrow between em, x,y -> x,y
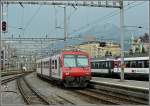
91,77 -> 149,90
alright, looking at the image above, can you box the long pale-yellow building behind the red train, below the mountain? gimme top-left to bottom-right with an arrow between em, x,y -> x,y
75,41 -> 121,58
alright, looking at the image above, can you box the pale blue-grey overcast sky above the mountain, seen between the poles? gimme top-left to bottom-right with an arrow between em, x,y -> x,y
4,1 -> 149,37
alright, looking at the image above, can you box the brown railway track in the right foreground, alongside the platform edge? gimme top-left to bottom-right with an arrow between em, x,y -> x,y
85,82 -> 149,105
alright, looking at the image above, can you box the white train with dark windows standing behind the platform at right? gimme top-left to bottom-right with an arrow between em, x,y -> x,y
91,57 -> 149,79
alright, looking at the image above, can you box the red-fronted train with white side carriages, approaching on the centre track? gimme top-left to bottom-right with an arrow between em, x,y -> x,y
36,51 -> 91,87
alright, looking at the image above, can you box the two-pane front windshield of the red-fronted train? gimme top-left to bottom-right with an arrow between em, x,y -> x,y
64,55 -> 88,67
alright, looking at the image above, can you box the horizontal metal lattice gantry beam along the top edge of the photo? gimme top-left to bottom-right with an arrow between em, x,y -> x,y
1,0 -> 121,8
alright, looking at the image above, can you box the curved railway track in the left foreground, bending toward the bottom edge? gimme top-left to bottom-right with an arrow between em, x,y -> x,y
17,77 -> 50,105
